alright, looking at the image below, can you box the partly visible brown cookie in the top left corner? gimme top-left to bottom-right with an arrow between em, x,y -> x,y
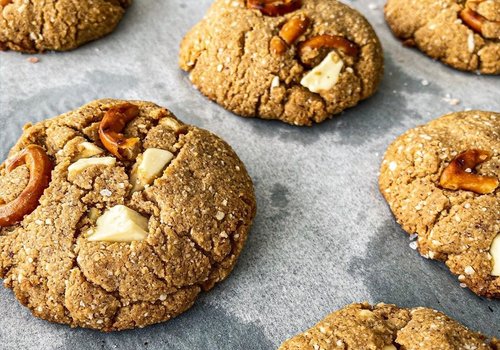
0,0 -> 132,53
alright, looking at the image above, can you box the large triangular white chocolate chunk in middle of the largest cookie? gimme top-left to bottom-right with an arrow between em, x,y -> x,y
88,205 -> 148,242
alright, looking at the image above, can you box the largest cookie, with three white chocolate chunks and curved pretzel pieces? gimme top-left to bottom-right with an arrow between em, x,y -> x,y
0,100 -> 255,331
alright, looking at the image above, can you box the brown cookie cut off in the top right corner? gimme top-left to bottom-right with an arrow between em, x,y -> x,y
385,0 -> 500,74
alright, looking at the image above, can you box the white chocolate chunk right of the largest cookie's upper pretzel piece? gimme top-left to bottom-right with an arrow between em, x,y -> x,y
131,148 -> 174,192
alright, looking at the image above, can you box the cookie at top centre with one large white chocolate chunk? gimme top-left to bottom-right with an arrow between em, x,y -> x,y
179,0 -> 383,125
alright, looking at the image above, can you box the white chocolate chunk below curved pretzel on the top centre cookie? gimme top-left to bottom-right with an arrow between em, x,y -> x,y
300,51 -> 344,93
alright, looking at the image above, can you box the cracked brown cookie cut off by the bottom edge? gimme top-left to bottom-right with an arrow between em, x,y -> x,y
280,303 -> 500,350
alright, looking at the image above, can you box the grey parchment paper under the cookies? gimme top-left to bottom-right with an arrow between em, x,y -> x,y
0,0 -> 500,350
